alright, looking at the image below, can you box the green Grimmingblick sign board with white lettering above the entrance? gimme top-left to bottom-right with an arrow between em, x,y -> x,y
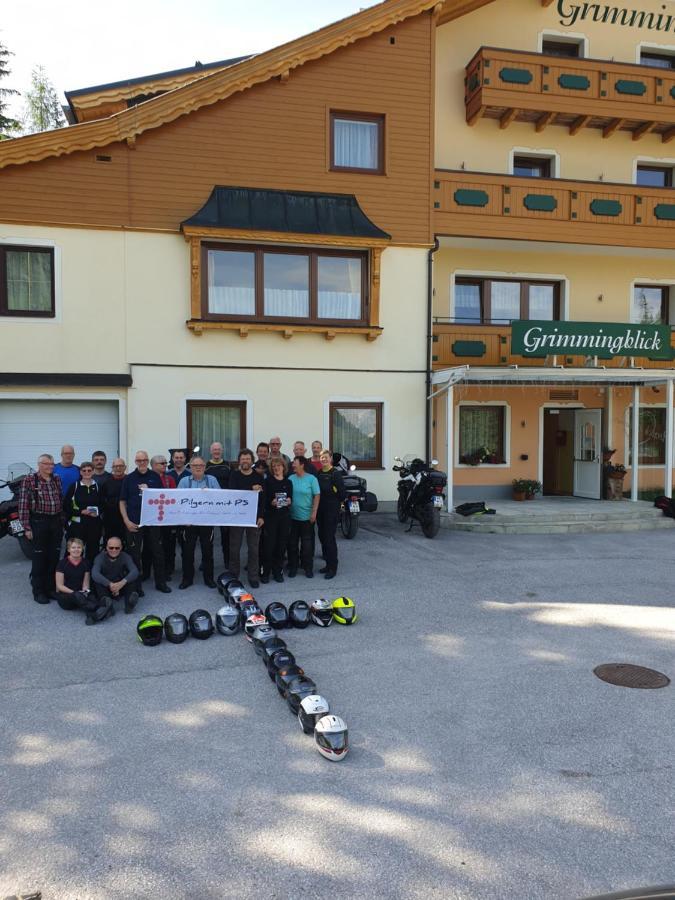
511,319 -> 673,359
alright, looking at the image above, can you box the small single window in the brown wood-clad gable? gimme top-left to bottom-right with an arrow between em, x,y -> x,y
330,112 -> 384,175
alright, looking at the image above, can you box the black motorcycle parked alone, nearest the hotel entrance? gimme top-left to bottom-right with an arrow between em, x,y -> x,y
393,456 -> 448,538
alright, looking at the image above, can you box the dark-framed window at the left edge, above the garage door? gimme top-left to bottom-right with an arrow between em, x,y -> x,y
0,245 -> 54,318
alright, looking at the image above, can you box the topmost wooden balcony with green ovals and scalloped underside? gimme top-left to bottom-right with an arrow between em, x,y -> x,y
465,47 -> 675,143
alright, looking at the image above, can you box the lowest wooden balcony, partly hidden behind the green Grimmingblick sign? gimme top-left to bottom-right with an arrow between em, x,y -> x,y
432,319 -> 675,369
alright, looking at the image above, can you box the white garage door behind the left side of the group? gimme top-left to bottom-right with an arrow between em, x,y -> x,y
0,400 -> 119,481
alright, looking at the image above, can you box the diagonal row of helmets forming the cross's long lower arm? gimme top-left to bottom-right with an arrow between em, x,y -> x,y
251,607 -> 349,762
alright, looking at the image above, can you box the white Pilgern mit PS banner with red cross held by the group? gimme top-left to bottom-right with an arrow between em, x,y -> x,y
141,488 -> 258,528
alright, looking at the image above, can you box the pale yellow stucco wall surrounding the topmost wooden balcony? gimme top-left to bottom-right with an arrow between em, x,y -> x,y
435,0 -> 675,184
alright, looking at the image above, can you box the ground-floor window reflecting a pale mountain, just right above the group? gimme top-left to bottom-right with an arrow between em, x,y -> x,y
330,403 -> 382,469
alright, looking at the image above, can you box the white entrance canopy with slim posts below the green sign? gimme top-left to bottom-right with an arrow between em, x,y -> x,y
427,365 -> 675,509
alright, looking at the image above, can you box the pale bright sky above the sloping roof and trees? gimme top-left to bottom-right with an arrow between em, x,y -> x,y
0,0 -> 375,117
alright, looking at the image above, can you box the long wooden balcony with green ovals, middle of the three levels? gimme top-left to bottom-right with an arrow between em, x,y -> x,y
433,169 -> 675,249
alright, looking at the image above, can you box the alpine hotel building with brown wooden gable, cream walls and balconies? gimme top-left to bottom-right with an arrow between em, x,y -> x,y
0,0 -> 675,503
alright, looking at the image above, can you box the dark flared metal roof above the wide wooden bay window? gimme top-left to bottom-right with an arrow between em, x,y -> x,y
181,187 -> 391,240
